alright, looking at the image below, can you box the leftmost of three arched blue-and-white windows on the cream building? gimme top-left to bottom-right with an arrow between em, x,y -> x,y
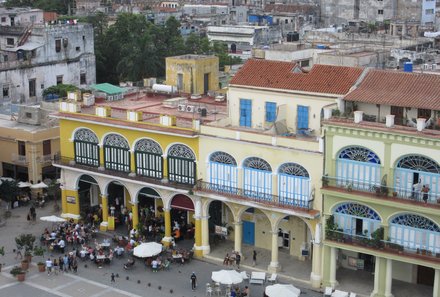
209,152 -> 238,193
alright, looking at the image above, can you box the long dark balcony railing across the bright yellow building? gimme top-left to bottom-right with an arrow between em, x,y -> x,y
53,157 -> 193,191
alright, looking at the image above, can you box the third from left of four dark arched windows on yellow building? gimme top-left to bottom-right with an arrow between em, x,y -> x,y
134,139 -> 163,179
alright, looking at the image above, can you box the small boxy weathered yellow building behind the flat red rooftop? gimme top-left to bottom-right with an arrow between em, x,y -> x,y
166,55 -> 219,94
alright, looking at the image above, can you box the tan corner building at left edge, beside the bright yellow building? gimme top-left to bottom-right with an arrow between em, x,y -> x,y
0,103 -> 60,183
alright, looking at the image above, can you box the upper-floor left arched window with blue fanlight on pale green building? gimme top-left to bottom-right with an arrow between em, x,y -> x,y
336,146 -> 381,190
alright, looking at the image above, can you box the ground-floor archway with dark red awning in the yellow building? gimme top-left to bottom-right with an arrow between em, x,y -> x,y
171,194 -> 195,244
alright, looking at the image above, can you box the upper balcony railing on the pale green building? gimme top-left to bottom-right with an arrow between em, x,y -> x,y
322,175 -> 440,206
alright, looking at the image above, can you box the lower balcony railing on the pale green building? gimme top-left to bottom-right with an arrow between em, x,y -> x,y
325,230 -> 440,263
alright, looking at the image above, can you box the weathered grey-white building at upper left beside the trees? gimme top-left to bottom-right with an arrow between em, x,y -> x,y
0,10 -> 96,103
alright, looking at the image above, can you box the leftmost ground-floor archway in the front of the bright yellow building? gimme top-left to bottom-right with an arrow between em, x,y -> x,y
78,174 -> 101,218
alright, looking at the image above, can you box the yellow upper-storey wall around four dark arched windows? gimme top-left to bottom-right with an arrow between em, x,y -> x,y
60,119 -> 198,176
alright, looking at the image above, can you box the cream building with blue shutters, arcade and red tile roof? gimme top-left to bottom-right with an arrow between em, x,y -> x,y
195,60 -> 362,287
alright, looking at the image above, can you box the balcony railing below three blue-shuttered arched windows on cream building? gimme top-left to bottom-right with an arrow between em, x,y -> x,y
194,180 -> 313,211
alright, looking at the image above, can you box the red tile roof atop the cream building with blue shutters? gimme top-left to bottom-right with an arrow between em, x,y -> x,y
230,59 -> 363,95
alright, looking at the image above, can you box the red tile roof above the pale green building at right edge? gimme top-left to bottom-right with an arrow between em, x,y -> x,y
344,69 -> 440,110
